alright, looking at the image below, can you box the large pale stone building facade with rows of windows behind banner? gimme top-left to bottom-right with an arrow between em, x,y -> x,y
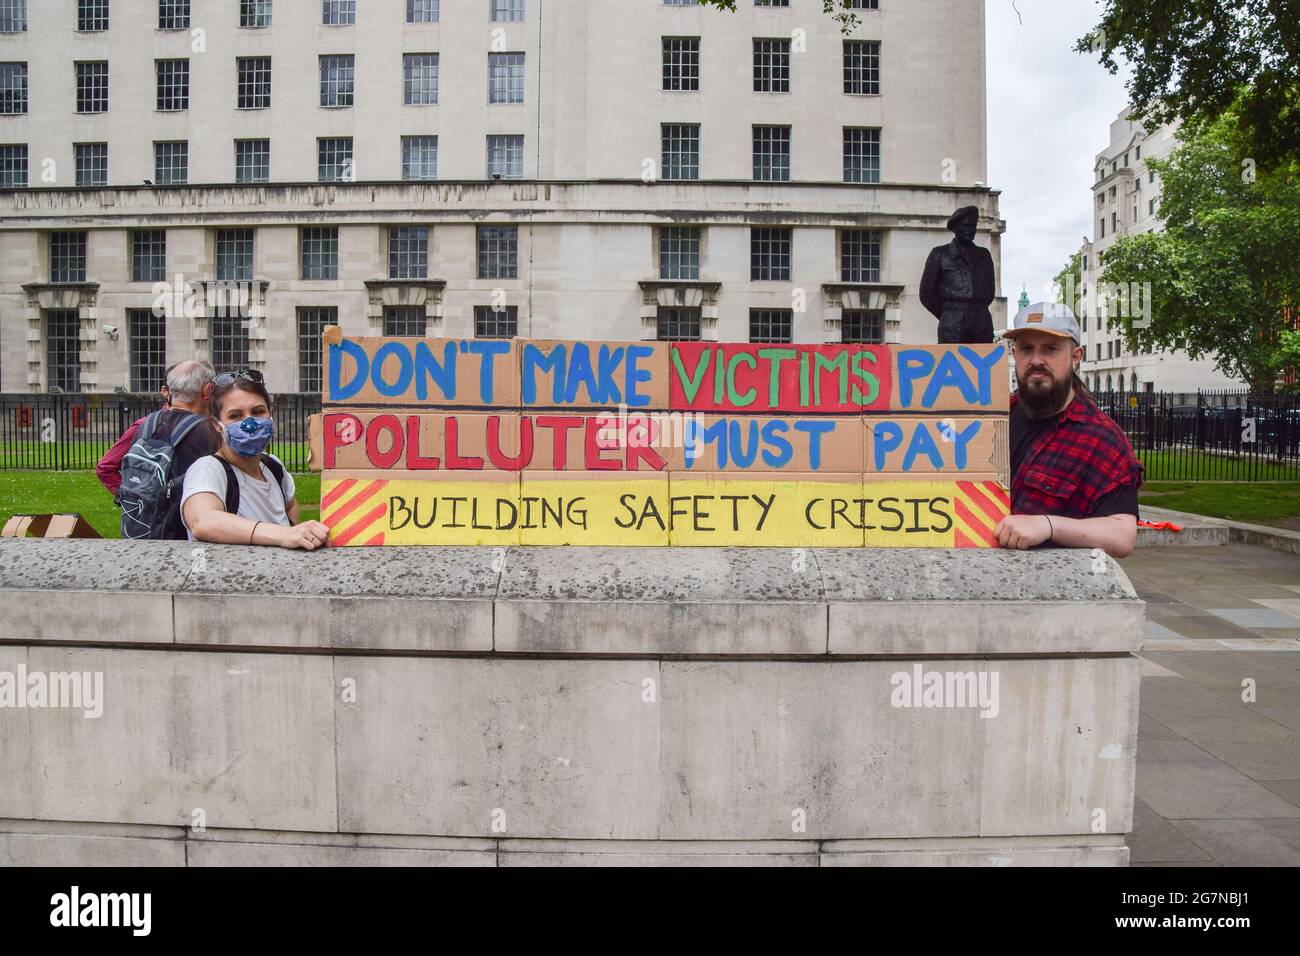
0,0 -> 1006,393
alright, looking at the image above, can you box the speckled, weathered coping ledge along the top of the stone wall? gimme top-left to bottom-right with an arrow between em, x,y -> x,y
0,538 -> 1143,657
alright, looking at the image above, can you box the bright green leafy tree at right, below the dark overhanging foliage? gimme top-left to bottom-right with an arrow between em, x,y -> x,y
1101,107 -> 1300,390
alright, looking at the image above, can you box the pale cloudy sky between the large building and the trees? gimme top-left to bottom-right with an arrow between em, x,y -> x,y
982,0 -> 1127,306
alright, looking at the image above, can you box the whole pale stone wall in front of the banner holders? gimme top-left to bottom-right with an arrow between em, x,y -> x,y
0,540 -> 1143,865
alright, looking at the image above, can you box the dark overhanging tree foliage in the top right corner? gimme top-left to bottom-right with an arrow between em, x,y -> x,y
1075,0 -> 1300,168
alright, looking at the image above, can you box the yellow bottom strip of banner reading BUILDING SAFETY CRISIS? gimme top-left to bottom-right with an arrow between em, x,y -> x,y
321,472 -> 1010,548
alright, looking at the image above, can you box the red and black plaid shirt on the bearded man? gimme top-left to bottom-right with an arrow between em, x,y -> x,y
1011,393 -> 1143,518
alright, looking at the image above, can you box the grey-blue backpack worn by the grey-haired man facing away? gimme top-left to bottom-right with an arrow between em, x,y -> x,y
117,411 -> 205,541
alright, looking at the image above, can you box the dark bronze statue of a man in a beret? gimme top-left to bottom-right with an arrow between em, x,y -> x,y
920,206 -> 993,345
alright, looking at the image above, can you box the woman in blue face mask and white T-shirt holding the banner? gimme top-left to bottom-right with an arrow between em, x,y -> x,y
181,371 -> 329,551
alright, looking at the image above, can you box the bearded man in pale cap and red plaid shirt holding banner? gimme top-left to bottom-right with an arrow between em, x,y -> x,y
996,302 -> 1143,558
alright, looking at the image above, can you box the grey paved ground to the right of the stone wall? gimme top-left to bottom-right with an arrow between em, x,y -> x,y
1121,544 -> 1300,866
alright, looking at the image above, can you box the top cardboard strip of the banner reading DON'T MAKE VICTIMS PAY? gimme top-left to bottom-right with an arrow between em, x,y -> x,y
322,326 -> 1009,415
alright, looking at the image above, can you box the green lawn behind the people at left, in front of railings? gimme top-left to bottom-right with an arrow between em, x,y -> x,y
0,471 -> 321,537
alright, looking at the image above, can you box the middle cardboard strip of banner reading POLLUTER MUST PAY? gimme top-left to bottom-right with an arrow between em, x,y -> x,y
311,411 -> 1008,479
